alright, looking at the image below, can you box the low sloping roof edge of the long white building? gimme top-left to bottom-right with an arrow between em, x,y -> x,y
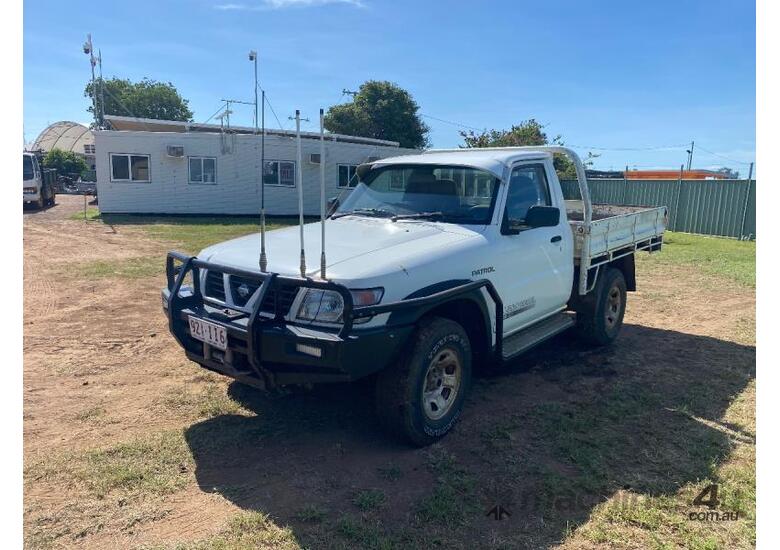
105,115 -> 399,147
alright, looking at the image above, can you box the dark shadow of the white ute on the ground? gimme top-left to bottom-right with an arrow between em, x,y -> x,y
186,325 -> 755,548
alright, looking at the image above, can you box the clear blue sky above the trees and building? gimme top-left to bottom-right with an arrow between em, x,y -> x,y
24,0 -> 755,176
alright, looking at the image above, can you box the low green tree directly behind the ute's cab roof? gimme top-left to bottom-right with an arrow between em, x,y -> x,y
460,118 -> 598,179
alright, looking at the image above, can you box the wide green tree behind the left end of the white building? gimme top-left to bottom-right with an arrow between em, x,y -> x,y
84,77 -> 192,122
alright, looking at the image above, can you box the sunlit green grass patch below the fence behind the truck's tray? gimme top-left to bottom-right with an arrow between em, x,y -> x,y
653,232 -> 756,288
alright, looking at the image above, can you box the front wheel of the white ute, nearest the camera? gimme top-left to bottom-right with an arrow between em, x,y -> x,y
376,317 -> 471,446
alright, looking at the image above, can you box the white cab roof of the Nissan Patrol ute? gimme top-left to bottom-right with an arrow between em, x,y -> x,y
372,147 -> 551,178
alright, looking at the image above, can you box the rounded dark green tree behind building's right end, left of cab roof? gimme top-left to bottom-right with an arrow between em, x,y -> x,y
325,80 -> 430,149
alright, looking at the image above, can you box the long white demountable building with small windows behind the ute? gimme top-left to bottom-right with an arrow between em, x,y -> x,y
93,115 -> 416,216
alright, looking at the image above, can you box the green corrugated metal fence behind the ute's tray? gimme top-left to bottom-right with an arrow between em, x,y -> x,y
562,179 -> 756,239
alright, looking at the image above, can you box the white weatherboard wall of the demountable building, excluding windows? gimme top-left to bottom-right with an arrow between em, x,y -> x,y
95,130 -> 416,216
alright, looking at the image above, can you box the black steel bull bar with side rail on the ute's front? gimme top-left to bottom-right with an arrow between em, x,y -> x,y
162,252 -> 503,387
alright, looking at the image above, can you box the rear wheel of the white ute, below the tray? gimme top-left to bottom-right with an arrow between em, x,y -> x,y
577,267 -> 626,346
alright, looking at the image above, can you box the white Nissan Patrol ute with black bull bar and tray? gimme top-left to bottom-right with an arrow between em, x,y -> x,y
162,146 -> 667,445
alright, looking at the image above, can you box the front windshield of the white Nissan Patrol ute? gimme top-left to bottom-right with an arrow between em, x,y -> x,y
334,164 -> 500,225
